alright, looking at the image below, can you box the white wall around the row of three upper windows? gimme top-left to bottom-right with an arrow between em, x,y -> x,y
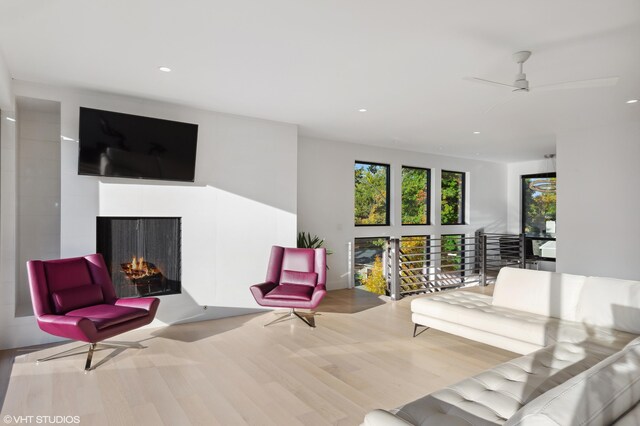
298,138 -> 507,289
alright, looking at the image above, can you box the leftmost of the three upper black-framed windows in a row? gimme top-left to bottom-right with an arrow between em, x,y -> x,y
354,161 -> 389,226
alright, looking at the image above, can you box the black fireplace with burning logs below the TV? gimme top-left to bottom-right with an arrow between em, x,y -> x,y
96,217 -> 181,297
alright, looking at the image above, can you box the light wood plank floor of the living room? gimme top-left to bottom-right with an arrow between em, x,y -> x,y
0,290 -> 517,426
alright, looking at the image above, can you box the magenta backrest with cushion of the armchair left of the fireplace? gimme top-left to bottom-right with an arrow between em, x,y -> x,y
27,254 -> 117,317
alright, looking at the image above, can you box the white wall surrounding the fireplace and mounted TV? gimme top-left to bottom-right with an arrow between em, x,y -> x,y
0,82 -> 297,348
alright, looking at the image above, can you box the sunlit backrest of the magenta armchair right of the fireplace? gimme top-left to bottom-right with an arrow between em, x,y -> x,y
266,246 -> 327,286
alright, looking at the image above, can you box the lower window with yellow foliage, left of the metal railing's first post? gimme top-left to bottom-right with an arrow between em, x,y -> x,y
353,237 -> 389,294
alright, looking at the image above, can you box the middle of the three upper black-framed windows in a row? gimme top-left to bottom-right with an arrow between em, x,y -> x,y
402,166 -> 431,225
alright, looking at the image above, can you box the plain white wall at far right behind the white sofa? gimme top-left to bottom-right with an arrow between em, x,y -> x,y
557,121 -> 640,280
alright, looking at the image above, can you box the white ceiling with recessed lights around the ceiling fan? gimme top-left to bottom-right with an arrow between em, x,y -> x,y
0,0 -> 640,161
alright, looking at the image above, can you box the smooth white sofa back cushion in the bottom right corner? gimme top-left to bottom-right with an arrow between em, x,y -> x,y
507,338 -> 640,426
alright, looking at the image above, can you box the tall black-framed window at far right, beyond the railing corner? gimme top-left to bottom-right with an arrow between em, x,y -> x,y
522,173 -> 556,260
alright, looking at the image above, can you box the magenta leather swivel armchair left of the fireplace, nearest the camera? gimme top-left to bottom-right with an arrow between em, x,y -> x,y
27,254 -> 160,371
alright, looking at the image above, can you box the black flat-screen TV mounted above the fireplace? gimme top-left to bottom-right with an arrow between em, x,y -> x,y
78,107 -> 198,182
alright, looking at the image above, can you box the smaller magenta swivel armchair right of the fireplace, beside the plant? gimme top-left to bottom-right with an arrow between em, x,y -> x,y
251,246 -> 327,327
